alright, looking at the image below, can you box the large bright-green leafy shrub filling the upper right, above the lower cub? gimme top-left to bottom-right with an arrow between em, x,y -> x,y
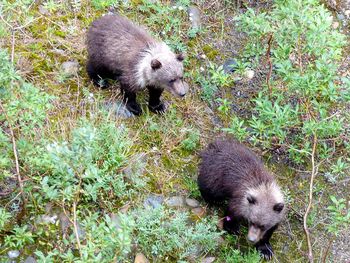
226,0 -> 349,163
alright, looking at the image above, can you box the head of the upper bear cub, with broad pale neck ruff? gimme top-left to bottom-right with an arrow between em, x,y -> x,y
139,43 -> 188,97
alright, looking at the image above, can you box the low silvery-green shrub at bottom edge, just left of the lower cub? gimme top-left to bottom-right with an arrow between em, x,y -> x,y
135,207 -> 221,261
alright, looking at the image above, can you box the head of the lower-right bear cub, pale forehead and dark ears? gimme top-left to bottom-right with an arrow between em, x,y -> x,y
242,182 -> 285,244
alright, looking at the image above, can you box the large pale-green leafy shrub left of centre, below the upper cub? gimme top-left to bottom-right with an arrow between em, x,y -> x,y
41,119 -> 144,202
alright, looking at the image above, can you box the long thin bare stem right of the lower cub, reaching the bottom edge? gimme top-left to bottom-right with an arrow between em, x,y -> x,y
304,133 -> 318,263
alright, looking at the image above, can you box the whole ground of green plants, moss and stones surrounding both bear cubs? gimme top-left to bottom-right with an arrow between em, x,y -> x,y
0,0 -> 350,262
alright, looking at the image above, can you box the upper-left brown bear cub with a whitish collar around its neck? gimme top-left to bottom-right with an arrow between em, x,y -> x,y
87,15 -> 188,115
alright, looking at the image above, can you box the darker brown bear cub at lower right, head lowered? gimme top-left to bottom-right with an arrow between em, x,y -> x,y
198,139 -> 285,259
